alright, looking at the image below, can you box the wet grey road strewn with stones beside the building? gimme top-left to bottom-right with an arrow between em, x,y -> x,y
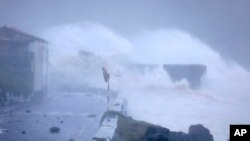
0,92 -> 110,141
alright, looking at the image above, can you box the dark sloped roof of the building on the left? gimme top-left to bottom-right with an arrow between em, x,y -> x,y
0,26 -> 47,43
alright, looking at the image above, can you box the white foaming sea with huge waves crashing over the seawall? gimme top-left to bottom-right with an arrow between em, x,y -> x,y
42,22 -> 250,141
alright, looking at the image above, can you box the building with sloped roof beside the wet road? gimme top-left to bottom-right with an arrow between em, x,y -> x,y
0,26 -> 48,101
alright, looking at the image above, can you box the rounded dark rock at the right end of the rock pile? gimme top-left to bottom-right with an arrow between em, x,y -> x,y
188,124 -> 214,141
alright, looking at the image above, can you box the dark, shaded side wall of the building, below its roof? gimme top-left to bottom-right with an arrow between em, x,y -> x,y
0,41 -> 33,97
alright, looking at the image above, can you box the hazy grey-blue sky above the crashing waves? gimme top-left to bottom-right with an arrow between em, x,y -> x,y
0,0 -> 250,70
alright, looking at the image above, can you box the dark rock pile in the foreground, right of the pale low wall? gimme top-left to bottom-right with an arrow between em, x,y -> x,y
109,113 -> 213,141
